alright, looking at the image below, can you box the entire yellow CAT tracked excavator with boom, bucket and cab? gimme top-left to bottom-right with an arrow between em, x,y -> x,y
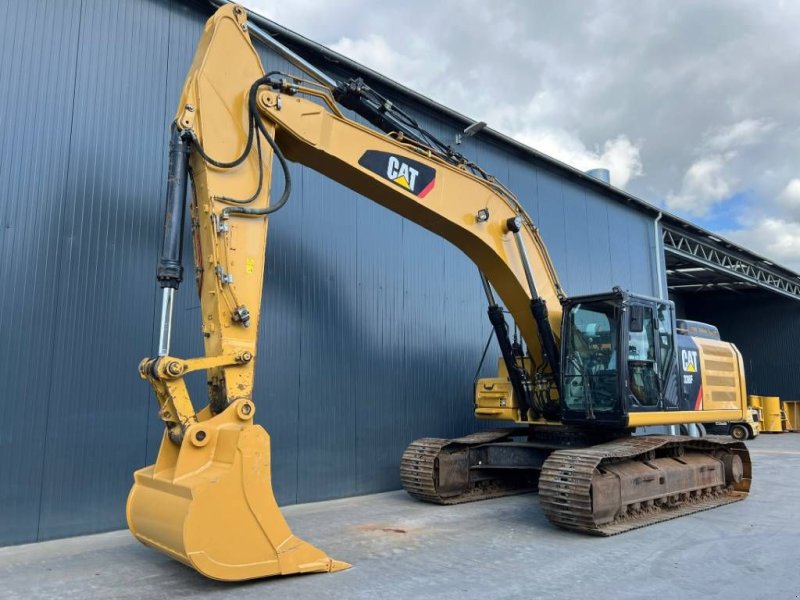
127,4 -> 751,580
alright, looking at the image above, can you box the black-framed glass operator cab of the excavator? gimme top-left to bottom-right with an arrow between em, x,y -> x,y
561,288 -> 679,428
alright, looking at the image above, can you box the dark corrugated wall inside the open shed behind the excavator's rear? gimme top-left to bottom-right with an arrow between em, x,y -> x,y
683,291 -> 800,400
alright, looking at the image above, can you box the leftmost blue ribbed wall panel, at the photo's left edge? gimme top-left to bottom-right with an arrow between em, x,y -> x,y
0,1 -> 80,543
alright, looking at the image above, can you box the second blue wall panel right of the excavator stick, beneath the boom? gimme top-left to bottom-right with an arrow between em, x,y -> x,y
296,170 -> 358,502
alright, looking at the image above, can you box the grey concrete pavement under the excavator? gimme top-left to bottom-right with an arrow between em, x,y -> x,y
0,434 -> 800,600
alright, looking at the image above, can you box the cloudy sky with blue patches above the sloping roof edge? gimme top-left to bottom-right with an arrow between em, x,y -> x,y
246,0 -> 800,271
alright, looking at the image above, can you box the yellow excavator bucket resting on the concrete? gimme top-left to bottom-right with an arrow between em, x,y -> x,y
127,400 -> 350,581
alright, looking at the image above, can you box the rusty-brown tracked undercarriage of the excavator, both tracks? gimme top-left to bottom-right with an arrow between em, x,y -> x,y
400,428 -> 751,536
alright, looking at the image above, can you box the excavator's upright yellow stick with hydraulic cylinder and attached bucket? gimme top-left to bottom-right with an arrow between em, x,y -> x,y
126,5 -> 350,581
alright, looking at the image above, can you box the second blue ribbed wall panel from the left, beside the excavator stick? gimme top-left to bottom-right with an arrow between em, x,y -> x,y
34,1 -> 175,539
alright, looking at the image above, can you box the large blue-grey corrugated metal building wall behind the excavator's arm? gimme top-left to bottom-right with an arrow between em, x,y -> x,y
0,0 -> 657,544
